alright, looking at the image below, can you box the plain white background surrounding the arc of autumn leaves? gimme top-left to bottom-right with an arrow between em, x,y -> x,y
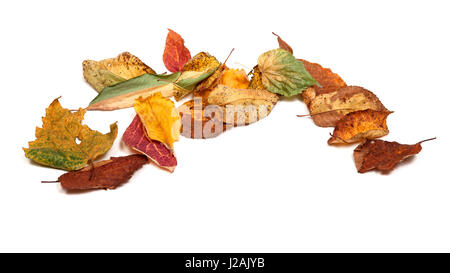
0,0 -> 450,252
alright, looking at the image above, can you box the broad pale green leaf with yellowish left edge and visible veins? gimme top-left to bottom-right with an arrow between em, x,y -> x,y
258,48 -> 317,96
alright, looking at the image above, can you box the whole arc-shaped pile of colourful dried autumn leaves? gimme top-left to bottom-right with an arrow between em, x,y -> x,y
24,29 -> 436,190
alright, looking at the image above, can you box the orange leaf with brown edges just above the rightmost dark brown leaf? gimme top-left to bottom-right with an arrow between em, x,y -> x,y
328,109 -> 392,145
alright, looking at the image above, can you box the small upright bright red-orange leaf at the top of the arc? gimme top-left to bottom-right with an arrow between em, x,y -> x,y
163,29 -> 191,72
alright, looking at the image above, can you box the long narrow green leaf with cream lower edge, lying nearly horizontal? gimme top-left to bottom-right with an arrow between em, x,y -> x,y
86,69 -> 214,111
